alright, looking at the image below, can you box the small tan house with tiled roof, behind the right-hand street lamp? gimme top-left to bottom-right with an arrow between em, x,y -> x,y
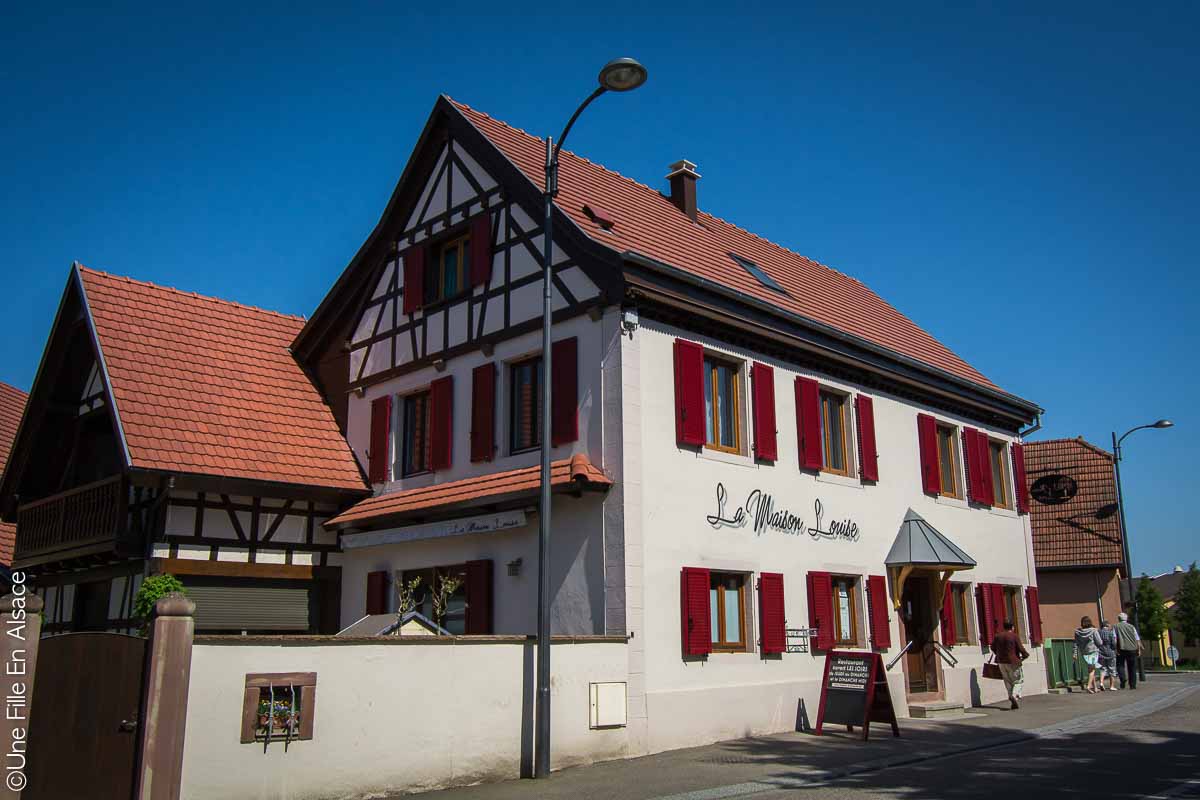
1025,438 -> 1124,639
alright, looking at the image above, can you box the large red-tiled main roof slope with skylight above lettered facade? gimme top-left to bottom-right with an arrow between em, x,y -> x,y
451,101 -> 997,389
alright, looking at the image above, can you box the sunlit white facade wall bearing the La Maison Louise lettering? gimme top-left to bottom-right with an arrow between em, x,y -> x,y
625,320 -> 1045,752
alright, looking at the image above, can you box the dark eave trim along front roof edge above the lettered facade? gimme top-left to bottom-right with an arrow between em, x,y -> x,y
623,251 -> 1043,428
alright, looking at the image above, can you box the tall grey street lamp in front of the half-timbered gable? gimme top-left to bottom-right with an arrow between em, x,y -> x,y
534,59 -> 647,777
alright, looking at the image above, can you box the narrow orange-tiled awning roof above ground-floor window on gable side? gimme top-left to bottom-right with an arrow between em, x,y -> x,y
325,453 -> 612,529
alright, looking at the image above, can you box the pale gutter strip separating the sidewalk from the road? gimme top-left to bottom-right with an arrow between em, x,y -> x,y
653,686 -> 1200,800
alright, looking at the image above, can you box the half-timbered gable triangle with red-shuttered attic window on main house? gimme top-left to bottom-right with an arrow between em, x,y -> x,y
348,136 -> 600,387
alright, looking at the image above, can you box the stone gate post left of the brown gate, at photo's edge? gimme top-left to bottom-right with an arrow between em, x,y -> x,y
0,585 -> 42,798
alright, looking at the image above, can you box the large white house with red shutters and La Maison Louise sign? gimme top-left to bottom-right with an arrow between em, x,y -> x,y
293,97 -> 1044,752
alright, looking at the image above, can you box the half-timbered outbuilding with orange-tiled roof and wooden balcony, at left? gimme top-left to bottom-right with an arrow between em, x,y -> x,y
0,265 -> 366,633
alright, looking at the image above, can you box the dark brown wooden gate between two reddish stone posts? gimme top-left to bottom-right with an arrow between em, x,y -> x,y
22,633 -> 146,800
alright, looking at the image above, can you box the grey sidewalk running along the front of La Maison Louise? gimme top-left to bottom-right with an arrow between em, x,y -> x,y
410,675 -> 1200,800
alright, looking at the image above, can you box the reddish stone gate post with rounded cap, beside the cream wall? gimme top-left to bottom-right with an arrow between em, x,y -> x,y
137,593 -> 196,800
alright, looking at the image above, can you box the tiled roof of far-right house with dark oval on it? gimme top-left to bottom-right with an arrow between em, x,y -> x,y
1025,439 -> 1122,567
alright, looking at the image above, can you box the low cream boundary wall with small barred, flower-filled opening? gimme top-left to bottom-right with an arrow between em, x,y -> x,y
181,639 -> 629,800
